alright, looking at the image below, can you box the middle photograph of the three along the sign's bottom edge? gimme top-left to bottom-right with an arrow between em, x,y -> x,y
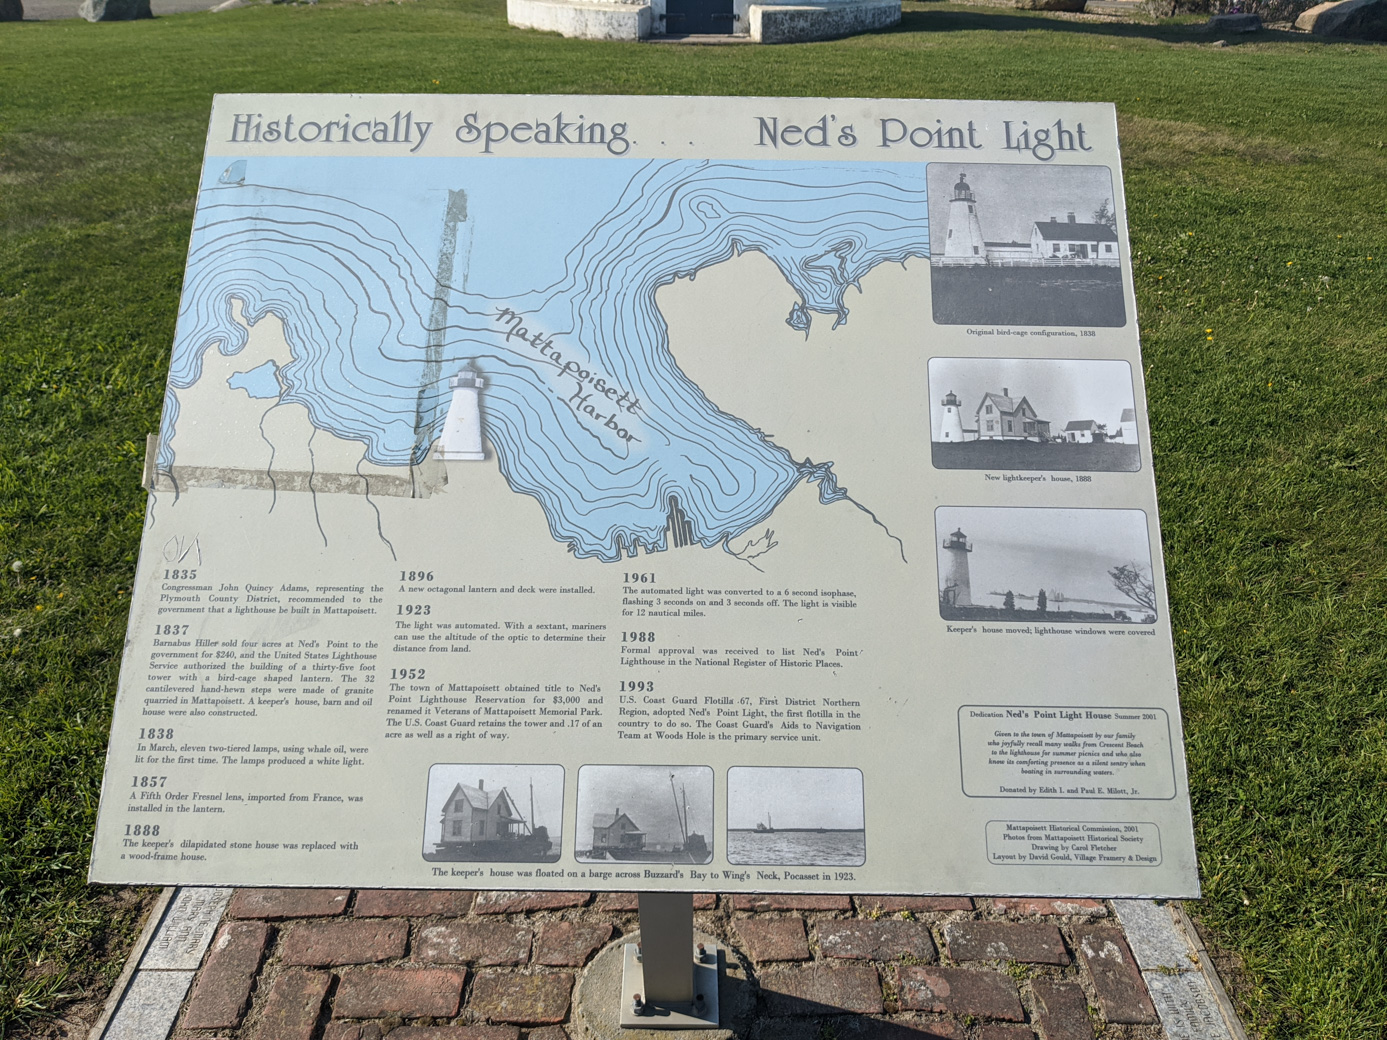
576,765 -> 713,864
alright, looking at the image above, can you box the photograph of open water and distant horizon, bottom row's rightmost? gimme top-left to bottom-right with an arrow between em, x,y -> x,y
727,765 -> 867,867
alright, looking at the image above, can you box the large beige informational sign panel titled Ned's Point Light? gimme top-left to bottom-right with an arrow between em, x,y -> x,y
92,94 -> 1198,896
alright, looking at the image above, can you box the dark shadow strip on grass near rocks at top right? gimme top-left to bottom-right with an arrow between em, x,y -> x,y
875,0 -> 1364,47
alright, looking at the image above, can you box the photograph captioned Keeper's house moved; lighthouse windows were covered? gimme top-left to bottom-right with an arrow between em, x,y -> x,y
935,506 -> 1158,625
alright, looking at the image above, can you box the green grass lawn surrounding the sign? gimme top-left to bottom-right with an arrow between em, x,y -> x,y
0,0 -> 1387,1040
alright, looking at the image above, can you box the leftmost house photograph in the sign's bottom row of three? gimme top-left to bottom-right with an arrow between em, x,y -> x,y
423,763 -> 563,863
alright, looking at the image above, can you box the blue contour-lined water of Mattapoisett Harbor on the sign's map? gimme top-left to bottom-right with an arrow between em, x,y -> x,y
160,158 -> 929,560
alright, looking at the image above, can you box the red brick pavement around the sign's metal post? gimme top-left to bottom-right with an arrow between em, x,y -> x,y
172,889 -> 1164,1040
